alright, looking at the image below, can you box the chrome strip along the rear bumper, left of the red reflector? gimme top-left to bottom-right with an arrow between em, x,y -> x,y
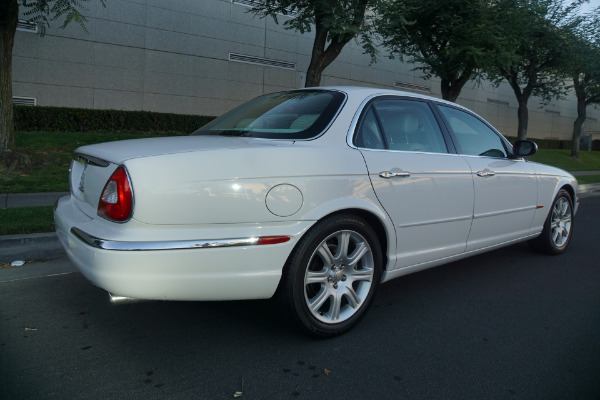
71,227 -> 258,251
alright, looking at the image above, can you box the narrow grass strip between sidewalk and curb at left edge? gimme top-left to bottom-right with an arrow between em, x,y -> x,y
0,206 -> 54,235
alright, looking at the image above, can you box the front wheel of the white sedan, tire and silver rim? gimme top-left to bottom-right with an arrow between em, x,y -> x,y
529,189 -> 573,255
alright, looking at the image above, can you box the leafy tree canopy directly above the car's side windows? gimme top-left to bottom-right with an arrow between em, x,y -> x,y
378,0 -> 513,101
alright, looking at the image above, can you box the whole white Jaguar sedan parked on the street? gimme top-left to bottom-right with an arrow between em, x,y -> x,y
55,87 -> 578,336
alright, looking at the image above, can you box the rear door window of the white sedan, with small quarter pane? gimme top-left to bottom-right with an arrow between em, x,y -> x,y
354,98 -> 448,153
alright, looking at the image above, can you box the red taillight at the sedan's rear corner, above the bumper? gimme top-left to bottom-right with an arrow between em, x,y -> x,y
98,167 -> 133,222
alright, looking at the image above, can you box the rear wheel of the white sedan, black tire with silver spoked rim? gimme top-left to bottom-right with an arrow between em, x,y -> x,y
276,214 -> 382,337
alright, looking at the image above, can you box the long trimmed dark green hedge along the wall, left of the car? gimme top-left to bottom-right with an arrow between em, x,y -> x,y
14,105 -> 215,133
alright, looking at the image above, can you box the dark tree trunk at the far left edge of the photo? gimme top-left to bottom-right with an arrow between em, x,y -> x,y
0,0 -> 19,155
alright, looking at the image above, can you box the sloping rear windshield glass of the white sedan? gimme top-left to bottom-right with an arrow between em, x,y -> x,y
192,90 -> 345,140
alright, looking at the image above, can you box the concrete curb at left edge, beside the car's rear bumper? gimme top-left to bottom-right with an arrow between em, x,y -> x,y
0,232 -> 65,263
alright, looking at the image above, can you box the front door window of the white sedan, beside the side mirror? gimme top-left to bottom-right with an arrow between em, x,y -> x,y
438,105 -> 508,157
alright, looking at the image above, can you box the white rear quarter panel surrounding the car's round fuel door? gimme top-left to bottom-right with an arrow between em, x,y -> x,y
125,142 -> 386,225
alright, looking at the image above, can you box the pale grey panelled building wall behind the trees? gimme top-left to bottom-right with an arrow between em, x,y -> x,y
13,0 -> 600,139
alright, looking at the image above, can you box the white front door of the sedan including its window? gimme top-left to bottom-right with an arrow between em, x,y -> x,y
439,105 -> 537,251
